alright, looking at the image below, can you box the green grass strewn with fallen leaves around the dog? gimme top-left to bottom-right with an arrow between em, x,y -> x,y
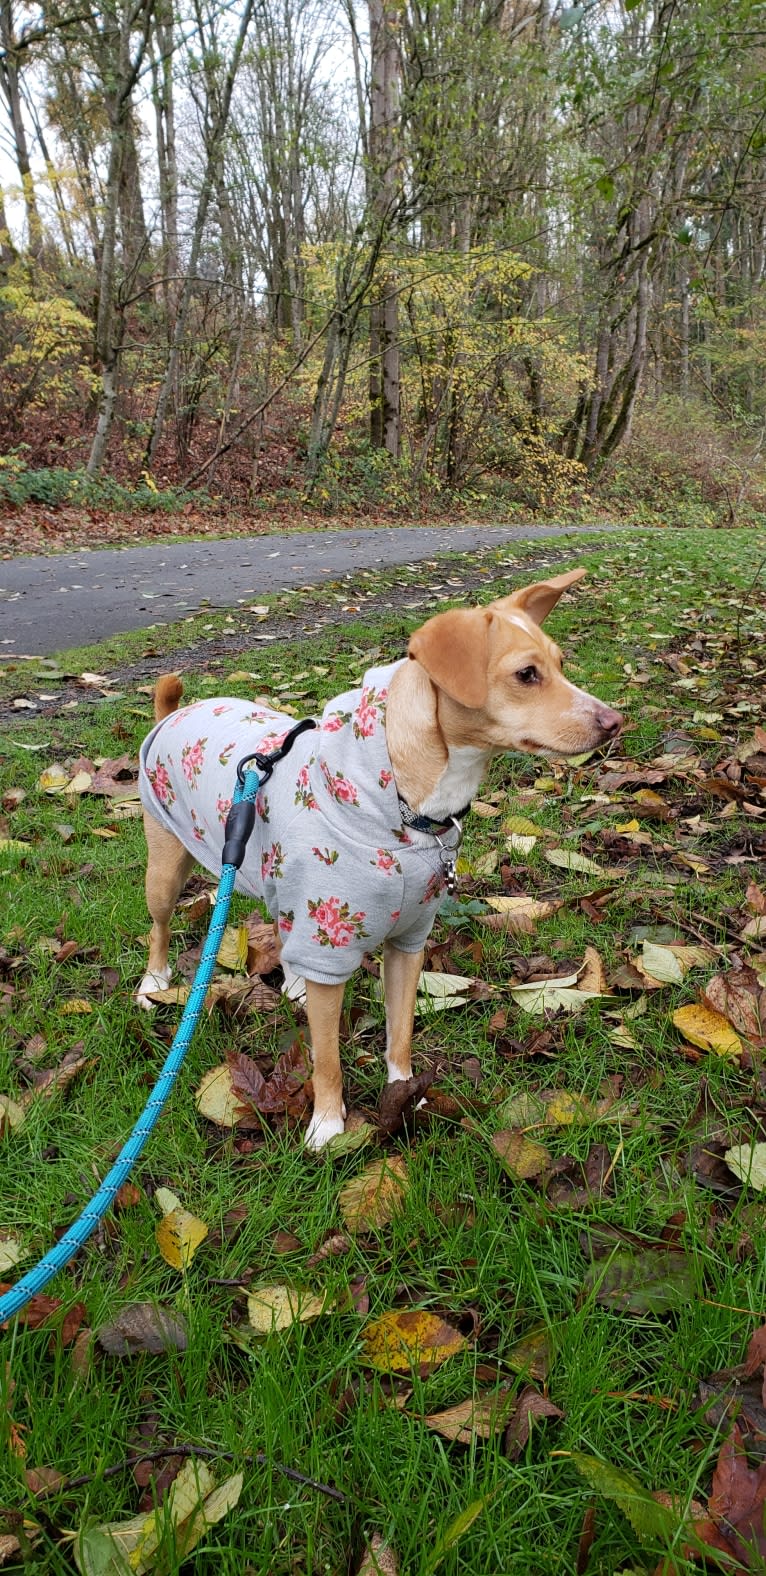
0,531 -> 766,1576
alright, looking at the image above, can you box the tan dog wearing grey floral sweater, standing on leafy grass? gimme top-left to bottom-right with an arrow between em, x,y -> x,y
137,569 -> 623,1150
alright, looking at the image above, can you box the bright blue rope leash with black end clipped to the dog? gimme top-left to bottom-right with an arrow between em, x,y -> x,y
0,719 -> 317,1322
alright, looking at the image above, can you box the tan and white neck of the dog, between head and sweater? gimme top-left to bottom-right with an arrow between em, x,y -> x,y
386,662 -> 492,820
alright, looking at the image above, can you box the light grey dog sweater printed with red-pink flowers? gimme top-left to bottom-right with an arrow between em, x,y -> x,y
139,663 -> 456,983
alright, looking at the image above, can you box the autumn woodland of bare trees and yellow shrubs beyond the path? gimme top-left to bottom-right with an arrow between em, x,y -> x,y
0,0 -> 766,525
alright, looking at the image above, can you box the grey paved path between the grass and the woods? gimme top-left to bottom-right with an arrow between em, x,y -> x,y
0,525 -> 617,657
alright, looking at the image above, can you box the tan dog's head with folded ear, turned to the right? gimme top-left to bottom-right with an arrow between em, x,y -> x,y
408,569 -> 623,755
